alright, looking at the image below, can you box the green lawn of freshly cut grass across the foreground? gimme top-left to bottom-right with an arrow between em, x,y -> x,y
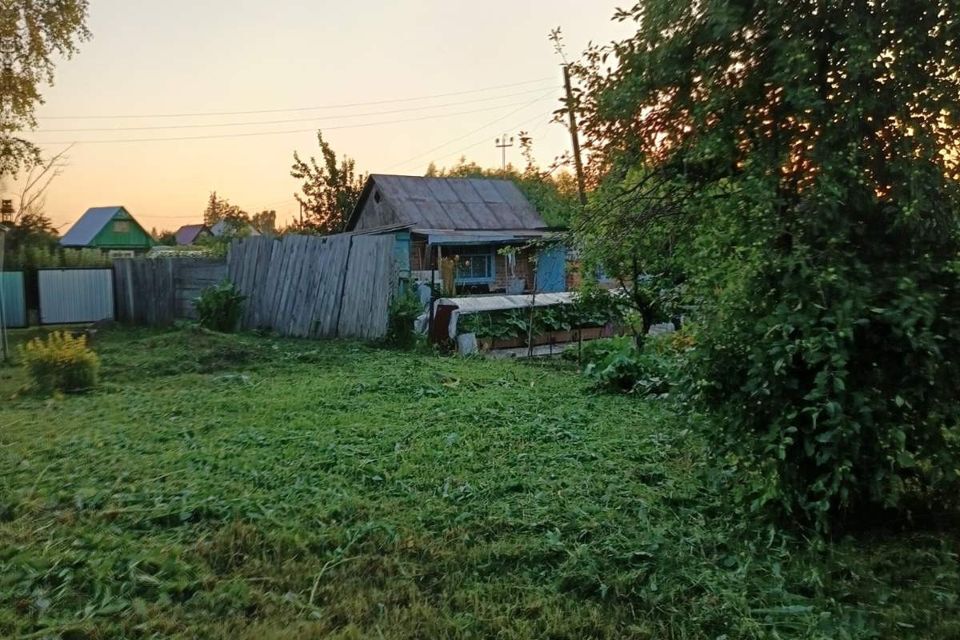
0,329 -> 960,640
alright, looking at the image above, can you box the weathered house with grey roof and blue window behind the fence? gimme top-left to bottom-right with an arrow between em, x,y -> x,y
346,174 -> 568,293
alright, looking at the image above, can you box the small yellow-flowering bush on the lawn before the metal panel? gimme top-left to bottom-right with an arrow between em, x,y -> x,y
20,331 -> 100,393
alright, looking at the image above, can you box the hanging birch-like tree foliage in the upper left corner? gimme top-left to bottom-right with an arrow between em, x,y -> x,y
0,0 -> 90,175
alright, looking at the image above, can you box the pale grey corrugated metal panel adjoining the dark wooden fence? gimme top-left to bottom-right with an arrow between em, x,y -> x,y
37,269 -> 113,324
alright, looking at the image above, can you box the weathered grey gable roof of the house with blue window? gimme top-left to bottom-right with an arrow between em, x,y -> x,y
347,174 -> 547,231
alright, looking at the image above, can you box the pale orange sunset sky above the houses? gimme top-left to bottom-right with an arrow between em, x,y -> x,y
8,0 -> 630,232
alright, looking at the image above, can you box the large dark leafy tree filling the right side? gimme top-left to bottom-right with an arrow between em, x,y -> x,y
578,0 -> 960,528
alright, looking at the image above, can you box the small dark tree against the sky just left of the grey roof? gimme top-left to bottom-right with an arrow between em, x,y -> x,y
290,131 -> 367,234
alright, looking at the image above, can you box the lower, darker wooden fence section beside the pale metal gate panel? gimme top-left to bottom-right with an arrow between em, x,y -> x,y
113,258 -> 227,326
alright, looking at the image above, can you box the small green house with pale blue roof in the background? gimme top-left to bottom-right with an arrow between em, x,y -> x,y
60,206 -> 156,257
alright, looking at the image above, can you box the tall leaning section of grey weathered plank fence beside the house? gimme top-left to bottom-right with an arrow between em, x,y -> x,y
227,234 -> 397,339
